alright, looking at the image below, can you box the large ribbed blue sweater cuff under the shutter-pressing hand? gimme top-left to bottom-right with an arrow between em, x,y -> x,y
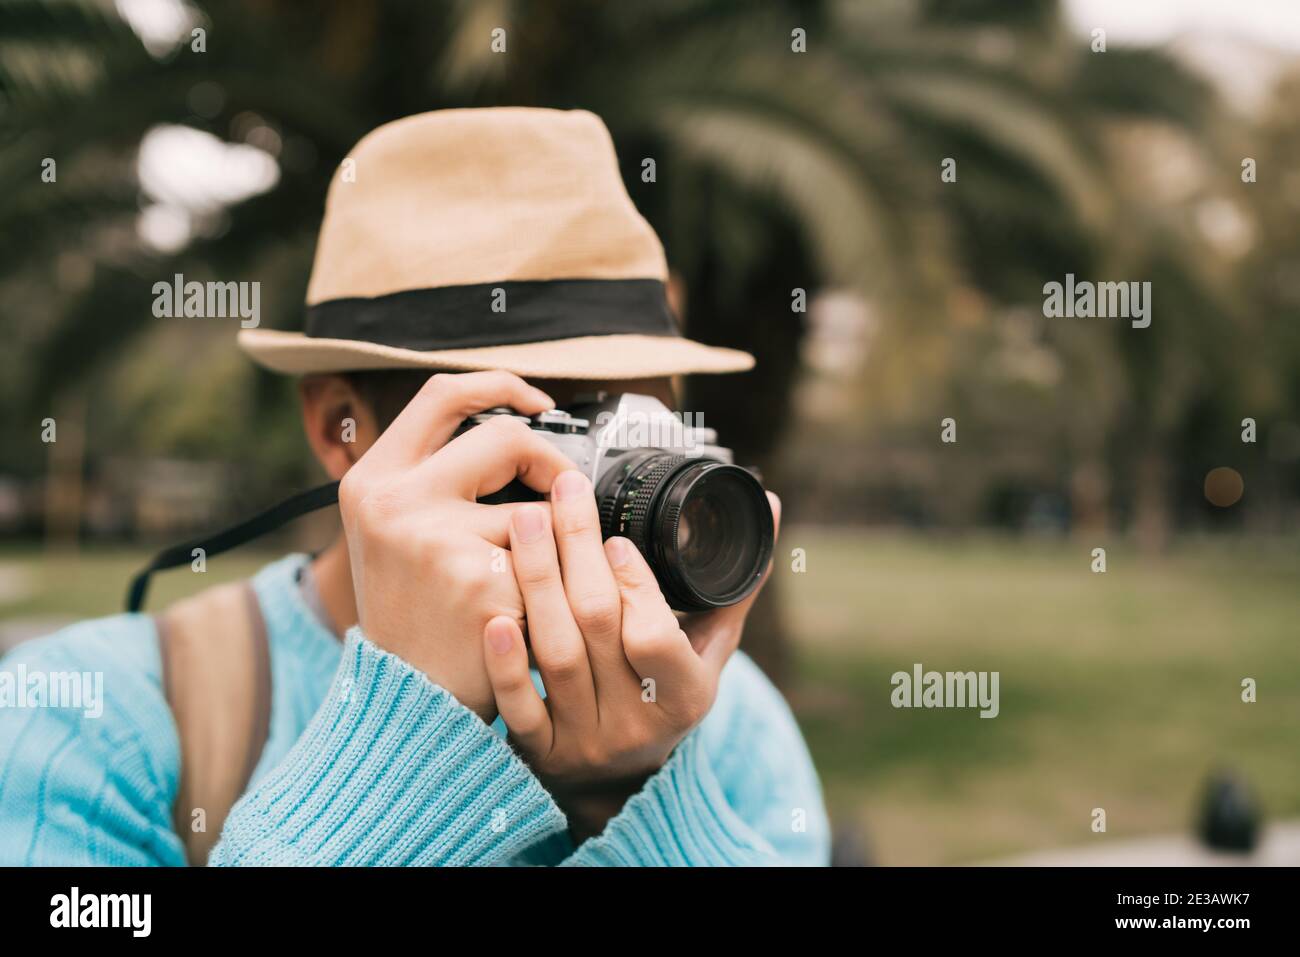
211,628 -> 567,866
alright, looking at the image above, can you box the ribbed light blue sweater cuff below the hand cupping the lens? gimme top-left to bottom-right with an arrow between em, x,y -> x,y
564,728 -> 779,867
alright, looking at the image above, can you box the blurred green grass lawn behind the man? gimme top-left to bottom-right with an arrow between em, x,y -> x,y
0,527 -> 1300,863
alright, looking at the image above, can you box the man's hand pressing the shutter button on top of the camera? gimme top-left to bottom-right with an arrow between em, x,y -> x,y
338,372 -> 573,722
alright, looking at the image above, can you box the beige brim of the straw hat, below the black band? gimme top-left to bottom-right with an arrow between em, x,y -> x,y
238,329 -> 754,380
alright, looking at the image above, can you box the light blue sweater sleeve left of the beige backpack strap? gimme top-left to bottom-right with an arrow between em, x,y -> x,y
0,615 -> 185,867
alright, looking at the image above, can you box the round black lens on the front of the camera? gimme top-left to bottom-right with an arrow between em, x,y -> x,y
597,451 -> 774,611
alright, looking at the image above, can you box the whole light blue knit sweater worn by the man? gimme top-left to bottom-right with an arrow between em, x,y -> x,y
0,555 -> 829,865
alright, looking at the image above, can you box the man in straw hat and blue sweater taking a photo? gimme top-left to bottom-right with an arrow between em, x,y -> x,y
0,109 -> 828,865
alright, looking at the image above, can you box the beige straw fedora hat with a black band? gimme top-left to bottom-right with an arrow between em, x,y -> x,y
239,108 -> 754,378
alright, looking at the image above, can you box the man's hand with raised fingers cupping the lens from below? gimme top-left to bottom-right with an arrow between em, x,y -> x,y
484,471 -> 780,840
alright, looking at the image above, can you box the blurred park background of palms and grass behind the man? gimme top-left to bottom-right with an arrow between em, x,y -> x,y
0,0 -> 1300,863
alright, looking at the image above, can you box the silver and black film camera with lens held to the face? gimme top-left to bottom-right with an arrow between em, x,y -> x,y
458,393 -> 775,611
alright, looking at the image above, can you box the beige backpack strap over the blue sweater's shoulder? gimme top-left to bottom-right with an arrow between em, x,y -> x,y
157,581 -> 270,865
